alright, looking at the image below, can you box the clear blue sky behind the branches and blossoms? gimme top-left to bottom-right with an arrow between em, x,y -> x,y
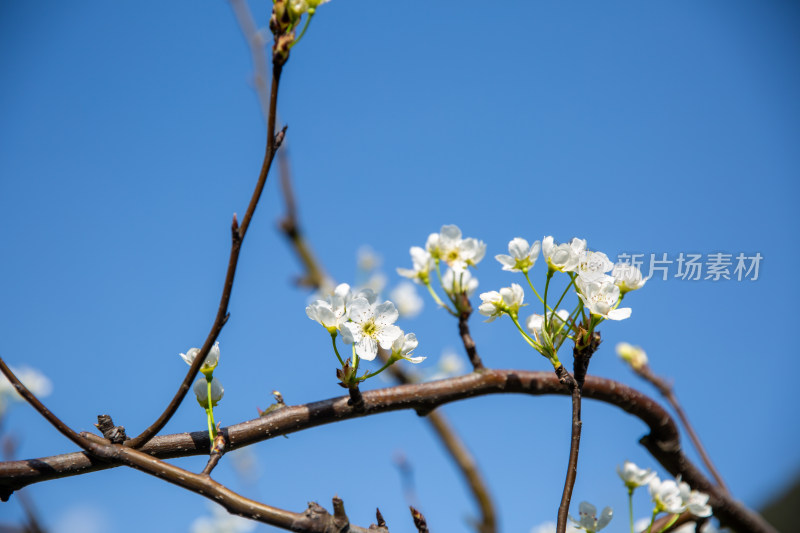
0,0 -> 800,532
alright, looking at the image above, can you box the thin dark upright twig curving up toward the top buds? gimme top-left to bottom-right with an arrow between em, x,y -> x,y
126,65 -> 282,448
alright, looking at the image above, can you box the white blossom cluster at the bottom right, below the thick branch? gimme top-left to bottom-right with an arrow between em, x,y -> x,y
617,461 -> 711,531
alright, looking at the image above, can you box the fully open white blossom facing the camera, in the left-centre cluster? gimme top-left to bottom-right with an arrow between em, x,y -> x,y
341,297 -> 403,361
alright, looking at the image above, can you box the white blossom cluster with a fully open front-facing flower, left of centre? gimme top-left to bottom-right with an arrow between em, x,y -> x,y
306,283 -> 425,388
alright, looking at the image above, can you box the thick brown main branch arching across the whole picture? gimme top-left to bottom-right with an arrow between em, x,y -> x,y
0,369 -> 775,533
